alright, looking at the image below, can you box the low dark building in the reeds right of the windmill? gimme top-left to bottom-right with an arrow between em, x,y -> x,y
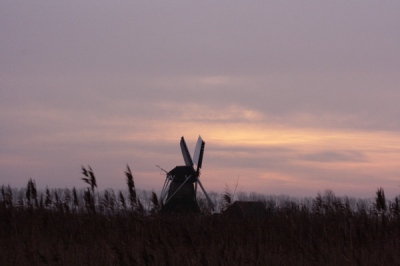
224,201 -> 267,218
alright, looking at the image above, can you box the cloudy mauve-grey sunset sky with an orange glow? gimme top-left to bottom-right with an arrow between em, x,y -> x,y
0,0 -> 400,197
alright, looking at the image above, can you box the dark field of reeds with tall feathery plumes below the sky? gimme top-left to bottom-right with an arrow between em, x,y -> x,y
0,168 -> 400,265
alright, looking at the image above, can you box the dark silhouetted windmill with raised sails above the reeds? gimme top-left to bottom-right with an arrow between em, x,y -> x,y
160,136 -> 215,212
